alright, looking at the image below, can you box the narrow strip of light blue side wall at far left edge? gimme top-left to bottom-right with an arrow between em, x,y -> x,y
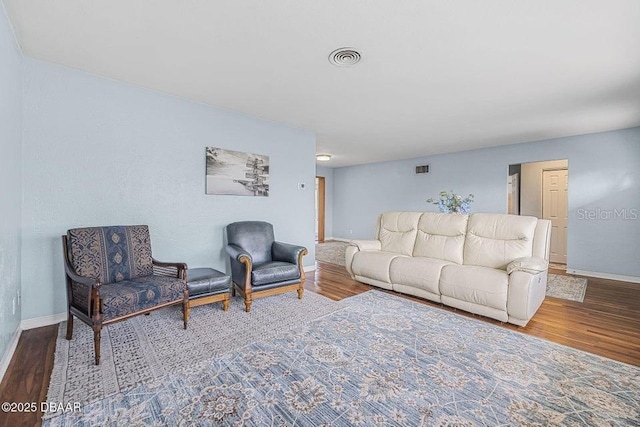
0,3 -> 22,360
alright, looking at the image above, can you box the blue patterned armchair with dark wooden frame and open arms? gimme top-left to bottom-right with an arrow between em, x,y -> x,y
62,225 -> 189,365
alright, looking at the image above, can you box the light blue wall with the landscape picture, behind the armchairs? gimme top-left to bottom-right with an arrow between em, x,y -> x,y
22,58 -> 315,319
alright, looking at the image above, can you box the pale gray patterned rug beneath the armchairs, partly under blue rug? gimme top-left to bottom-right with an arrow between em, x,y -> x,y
47,292 -> 340,416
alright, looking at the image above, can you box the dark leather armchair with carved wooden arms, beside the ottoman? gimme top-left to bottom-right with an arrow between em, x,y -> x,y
227,221 -> 307,312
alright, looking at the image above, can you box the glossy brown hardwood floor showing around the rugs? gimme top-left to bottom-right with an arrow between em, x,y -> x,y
0,262 -> 640,427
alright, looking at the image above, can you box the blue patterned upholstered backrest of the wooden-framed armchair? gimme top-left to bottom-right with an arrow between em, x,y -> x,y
67,225 -> 153,283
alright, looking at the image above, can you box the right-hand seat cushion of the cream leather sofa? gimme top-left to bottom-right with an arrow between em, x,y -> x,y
440,265 -> 509,312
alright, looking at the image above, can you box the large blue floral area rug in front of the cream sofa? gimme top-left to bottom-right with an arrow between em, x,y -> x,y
44,291 -> 640,426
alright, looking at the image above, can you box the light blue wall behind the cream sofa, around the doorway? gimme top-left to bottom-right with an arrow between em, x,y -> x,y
333,128 -> 640,277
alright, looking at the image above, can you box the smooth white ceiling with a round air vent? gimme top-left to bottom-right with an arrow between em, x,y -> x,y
3,0 -> 640,167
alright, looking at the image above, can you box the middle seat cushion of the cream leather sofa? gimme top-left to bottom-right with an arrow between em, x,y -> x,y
390,257 -> 452,295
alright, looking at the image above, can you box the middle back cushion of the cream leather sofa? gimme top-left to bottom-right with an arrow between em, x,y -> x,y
413,212 -> 469,264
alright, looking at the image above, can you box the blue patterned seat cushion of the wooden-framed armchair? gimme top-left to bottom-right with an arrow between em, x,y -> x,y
100,275 -> 184,321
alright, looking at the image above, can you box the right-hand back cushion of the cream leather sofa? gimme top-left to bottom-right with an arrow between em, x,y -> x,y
464,214 -> 538,269
